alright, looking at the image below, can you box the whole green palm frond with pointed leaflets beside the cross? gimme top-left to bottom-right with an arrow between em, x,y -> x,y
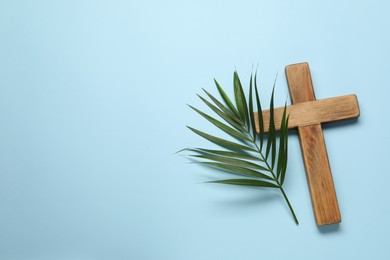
185,71 -> 298,224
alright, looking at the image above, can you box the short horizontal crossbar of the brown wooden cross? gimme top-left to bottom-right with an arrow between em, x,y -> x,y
255,95 -> 360,132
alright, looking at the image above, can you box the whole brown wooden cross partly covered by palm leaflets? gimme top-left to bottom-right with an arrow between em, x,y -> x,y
255,62 -> 360,226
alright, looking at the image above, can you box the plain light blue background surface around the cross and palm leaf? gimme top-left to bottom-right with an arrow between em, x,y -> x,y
0,0 -> 390,260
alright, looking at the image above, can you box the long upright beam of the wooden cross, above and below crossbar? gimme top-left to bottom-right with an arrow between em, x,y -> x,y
286,63 -> 341,226
